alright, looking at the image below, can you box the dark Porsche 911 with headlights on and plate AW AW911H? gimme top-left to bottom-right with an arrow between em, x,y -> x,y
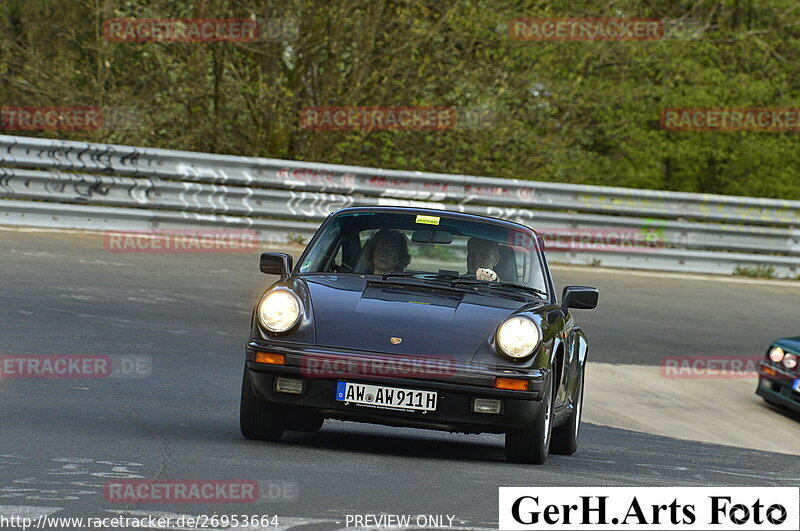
240,207 -> 598,463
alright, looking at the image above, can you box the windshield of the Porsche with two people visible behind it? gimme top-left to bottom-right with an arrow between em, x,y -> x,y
299,212 -> 548,295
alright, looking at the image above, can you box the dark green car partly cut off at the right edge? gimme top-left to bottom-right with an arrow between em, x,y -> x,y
756,337 -> 800,412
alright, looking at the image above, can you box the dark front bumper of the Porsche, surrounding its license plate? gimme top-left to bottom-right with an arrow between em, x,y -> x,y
246,343 -> 548,433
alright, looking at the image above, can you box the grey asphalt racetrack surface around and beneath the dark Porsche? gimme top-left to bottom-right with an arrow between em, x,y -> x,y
0,230 -> 800,529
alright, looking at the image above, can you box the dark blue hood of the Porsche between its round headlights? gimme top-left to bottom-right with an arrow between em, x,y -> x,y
304,275 -> 535,361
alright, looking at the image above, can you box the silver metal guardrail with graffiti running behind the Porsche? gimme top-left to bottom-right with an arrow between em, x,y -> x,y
0,135 -> 800,278
